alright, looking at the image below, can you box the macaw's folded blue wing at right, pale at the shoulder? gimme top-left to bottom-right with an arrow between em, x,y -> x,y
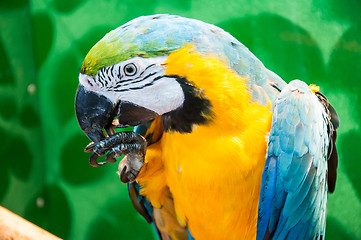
257,80 -> 330,239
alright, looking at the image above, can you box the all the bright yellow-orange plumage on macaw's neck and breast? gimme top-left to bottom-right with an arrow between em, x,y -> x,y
138,47 -> 272,240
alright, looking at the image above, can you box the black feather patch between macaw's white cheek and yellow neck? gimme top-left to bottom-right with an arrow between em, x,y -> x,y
162,75 -> 212,133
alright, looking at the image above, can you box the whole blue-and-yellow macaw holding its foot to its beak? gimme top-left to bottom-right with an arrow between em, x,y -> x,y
75,15 -> 339,240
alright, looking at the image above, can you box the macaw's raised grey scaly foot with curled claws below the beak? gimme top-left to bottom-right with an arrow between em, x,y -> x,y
84,132 -> 147,182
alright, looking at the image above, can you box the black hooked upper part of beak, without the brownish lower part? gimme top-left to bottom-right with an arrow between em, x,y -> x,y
75,84 -> 116,142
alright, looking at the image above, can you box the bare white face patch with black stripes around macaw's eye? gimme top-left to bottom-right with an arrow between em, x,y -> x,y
79,56 -> 184,115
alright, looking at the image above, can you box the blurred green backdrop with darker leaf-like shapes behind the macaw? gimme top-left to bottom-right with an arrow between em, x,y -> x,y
0,0 -> 361,240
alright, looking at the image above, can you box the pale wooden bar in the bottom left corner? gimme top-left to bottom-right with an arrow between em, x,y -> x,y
0,206 -> 60,240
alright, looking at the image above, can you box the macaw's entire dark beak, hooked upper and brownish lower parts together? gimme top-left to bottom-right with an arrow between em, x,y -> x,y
75,84 -> 158,142
